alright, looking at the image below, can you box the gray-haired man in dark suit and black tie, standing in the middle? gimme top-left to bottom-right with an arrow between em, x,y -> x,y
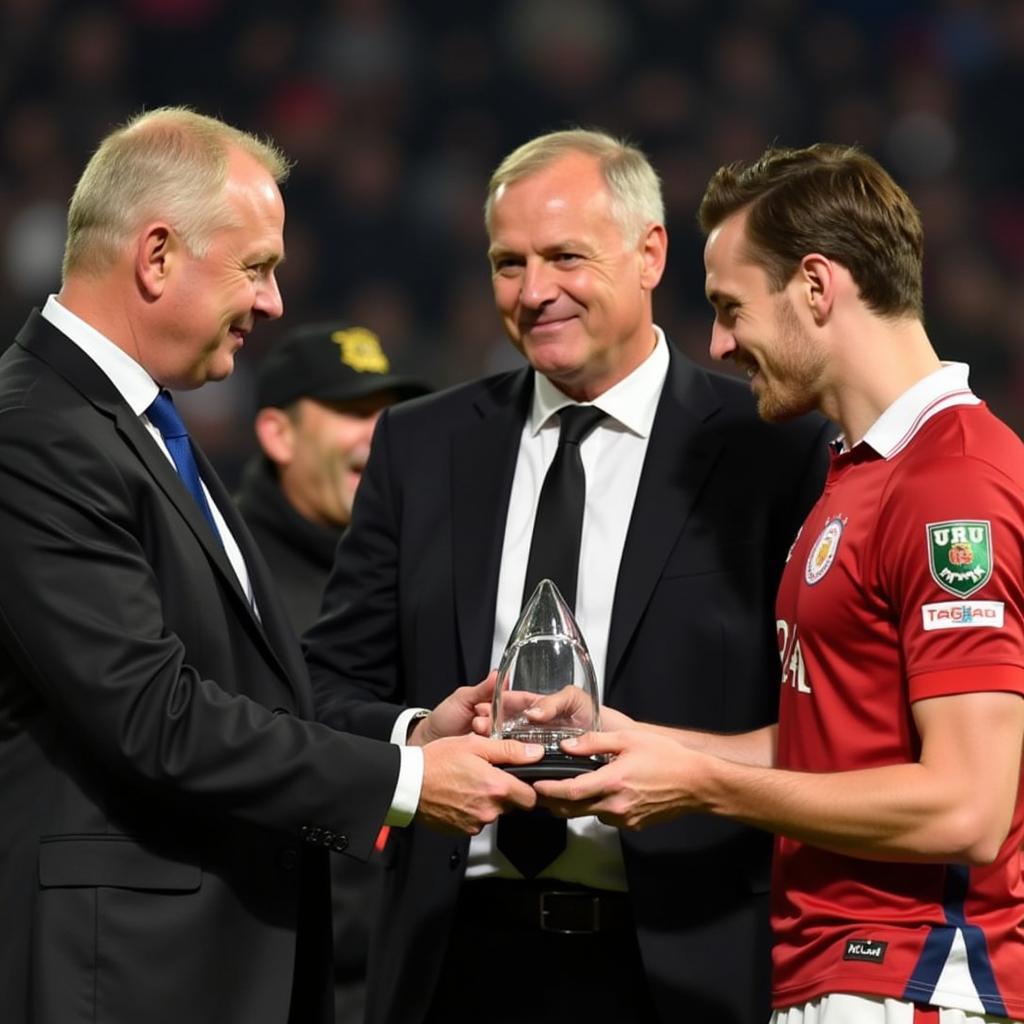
307,131 -> 827,1024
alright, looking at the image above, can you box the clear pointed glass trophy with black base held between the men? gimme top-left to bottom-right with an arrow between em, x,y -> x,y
490,580 -> 607,781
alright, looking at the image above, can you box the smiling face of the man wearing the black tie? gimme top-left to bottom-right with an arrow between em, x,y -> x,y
488,153 -> 666,400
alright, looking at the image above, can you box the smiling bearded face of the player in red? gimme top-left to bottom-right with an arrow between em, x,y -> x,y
705,211 -> 826,422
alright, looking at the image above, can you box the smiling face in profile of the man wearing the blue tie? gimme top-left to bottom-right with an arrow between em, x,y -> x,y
149,151 -> 285,388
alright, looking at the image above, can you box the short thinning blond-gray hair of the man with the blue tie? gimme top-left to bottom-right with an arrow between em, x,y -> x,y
63,106 -> 290,276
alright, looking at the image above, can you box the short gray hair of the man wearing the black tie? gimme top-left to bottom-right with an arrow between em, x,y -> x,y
483,128 -> 665,246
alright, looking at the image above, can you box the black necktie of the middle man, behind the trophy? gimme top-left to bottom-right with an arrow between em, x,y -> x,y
498,406 -> 605,879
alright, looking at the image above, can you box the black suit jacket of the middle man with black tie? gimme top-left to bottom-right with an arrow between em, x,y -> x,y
307,353 -> 828,1024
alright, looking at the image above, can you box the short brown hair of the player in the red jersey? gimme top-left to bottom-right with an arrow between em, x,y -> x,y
697,142 -> 924,319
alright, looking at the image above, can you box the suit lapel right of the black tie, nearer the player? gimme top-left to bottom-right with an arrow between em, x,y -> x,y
604,345 -> 724,695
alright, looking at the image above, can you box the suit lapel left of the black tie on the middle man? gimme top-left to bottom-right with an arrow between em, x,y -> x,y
452,370 -> 534,683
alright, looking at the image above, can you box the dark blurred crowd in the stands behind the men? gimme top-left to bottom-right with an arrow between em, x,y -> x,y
0,0 -> 1024,483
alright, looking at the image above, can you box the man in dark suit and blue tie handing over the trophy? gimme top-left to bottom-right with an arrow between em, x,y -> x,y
0,109 -> 540,1024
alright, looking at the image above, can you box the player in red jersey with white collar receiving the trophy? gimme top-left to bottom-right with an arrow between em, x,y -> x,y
535,144 -> 1024,1024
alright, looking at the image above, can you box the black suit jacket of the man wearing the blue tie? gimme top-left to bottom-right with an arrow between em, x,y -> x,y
0,313 -> 398,1024
